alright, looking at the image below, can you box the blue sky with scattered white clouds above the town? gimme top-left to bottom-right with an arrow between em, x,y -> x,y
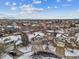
0,0 -> 79,19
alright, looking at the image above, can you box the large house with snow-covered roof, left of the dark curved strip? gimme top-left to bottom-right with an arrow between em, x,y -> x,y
0,35 -> 22,51
